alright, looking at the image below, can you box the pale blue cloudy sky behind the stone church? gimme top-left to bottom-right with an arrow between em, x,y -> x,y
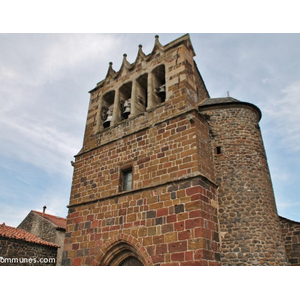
0,32 -> 300,226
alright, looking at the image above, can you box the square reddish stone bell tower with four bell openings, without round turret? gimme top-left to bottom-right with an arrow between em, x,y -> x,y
63,34 -> 220,265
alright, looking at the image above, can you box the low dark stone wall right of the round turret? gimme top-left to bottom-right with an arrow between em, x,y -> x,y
280,217 -> 300,266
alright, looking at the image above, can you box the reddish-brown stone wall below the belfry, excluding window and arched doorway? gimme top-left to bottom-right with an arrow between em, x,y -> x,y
63,109 -> 220,265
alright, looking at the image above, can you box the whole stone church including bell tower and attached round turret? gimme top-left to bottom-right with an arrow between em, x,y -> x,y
62,35 -> 286,265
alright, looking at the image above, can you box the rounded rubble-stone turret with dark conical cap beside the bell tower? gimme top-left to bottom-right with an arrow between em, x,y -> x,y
199,97 -> 287,265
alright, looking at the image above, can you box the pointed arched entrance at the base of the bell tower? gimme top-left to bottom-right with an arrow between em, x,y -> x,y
100,241 -> 145,266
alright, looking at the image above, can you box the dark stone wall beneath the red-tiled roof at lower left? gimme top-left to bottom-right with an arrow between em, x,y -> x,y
0,237 -> 57,266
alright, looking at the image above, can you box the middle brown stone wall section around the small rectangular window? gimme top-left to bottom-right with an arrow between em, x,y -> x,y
70,107 -> 214,206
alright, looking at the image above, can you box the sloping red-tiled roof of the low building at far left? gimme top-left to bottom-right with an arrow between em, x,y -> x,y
0,223 -> 59,248
